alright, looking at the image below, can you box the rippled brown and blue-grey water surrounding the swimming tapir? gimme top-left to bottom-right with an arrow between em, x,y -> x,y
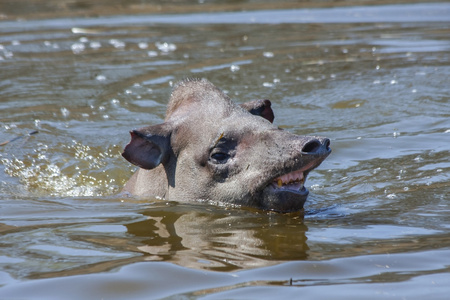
0,0 -> 450,299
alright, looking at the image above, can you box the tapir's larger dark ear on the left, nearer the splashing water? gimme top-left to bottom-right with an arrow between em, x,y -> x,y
122,123 -> 172,170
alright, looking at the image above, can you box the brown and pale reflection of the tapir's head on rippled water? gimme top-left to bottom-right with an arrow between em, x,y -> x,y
126,207 -> 308,271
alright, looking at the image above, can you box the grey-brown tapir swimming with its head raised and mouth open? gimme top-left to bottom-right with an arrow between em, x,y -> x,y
122,79 -> 331,212
